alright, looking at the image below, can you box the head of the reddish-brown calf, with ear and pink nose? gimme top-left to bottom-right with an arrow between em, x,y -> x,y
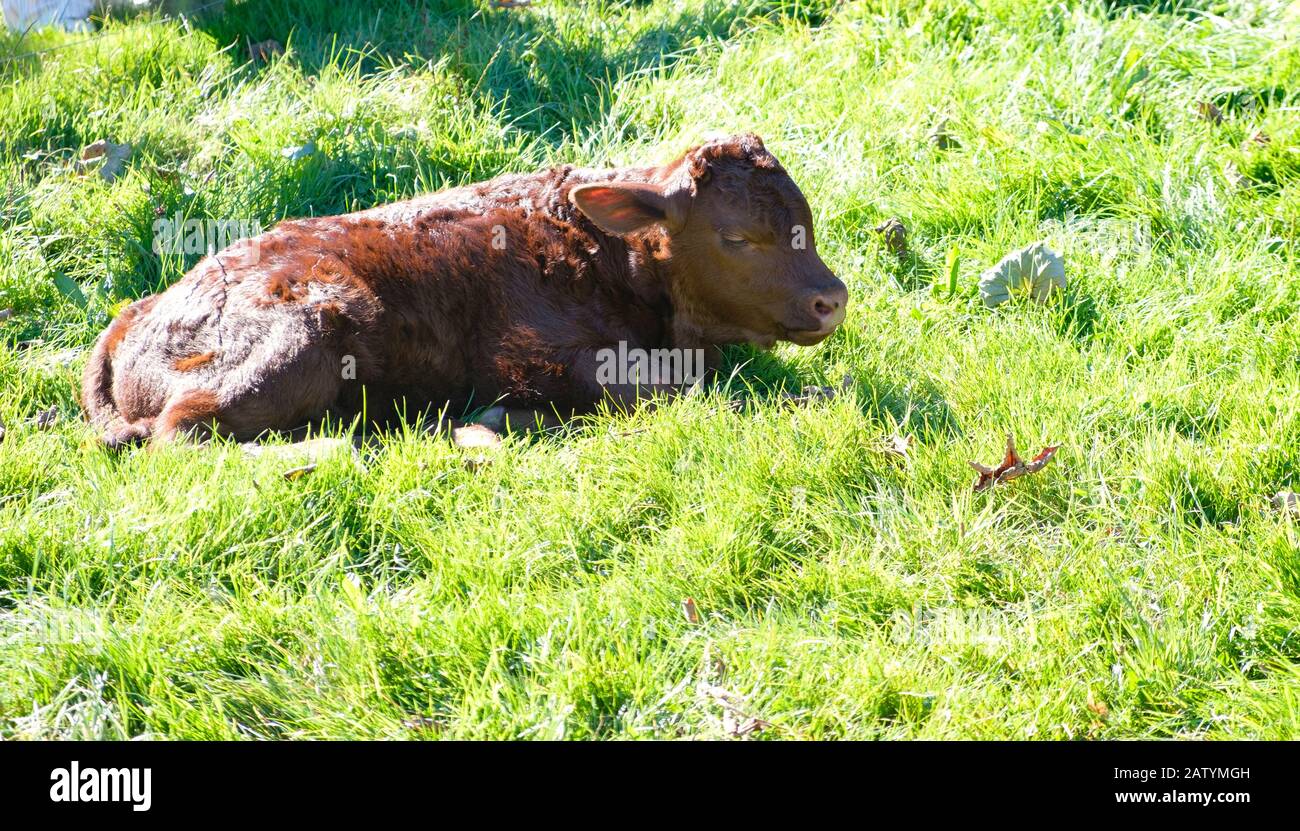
569,135 -> 849,346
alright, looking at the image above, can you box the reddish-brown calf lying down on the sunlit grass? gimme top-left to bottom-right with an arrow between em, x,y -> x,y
82,135 -> 848,446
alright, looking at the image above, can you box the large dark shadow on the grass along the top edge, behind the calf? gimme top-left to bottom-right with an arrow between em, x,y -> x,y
198,0 -> 835,146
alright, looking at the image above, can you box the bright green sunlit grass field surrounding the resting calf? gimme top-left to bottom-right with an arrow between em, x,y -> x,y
0,0 -> 1300,739
